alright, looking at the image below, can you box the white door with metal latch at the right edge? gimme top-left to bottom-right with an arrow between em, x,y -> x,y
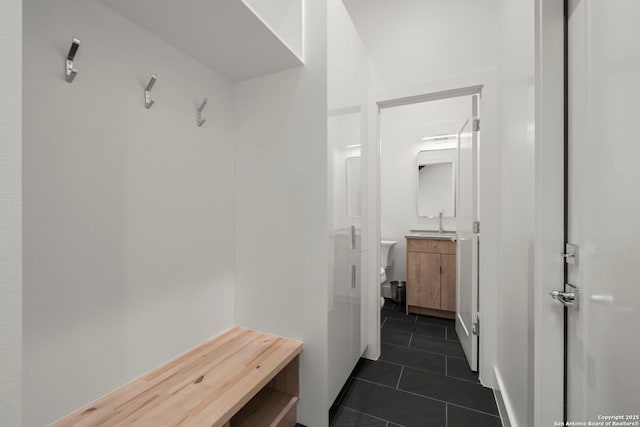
567,0 -> 640,425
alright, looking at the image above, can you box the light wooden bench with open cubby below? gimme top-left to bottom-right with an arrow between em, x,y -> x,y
53,328 -> 302,427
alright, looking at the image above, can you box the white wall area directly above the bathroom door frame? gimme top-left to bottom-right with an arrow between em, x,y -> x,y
344,0 -> 498,90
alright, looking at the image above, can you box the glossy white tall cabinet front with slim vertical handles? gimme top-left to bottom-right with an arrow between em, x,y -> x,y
327,111 -> 365,402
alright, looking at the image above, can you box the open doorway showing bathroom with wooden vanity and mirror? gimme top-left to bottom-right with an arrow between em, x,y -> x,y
377,86 -> 482,375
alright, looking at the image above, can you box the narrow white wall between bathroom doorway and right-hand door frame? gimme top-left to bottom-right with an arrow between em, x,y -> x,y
496,0 -> 536,426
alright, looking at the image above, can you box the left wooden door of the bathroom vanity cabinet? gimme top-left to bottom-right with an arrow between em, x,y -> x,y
407,252 -> 440,309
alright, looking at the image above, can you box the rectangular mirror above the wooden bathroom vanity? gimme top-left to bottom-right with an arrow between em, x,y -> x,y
417,149 -> 456,217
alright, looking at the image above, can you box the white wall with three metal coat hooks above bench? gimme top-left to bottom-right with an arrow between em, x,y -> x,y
23,0 -> 235,426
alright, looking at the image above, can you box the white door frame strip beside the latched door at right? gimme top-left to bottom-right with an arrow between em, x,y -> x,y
528,0 -> 566,426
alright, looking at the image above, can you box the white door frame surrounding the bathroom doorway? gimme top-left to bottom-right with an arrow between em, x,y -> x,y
363,71 -> 499,388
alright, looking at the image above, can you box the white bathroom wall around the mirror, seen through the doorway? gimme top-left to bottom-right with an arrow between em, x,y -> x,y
380,96 -> 471,297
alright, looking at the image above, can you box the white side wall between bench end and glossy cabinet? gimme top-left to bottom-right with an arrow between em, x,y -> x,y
232,2 -> 328,426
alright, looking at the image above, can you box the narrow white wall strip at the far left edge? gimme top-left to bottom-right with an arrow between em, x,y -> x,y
0,0 -> 22,427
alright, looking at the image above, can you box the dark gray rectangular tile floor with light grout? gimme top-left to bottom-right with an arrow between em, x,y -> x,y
330,300 -> 502,427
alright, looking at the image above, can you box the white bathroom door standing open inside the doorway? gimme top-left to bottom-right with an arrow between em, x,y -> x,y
456,95 -> 478,371
